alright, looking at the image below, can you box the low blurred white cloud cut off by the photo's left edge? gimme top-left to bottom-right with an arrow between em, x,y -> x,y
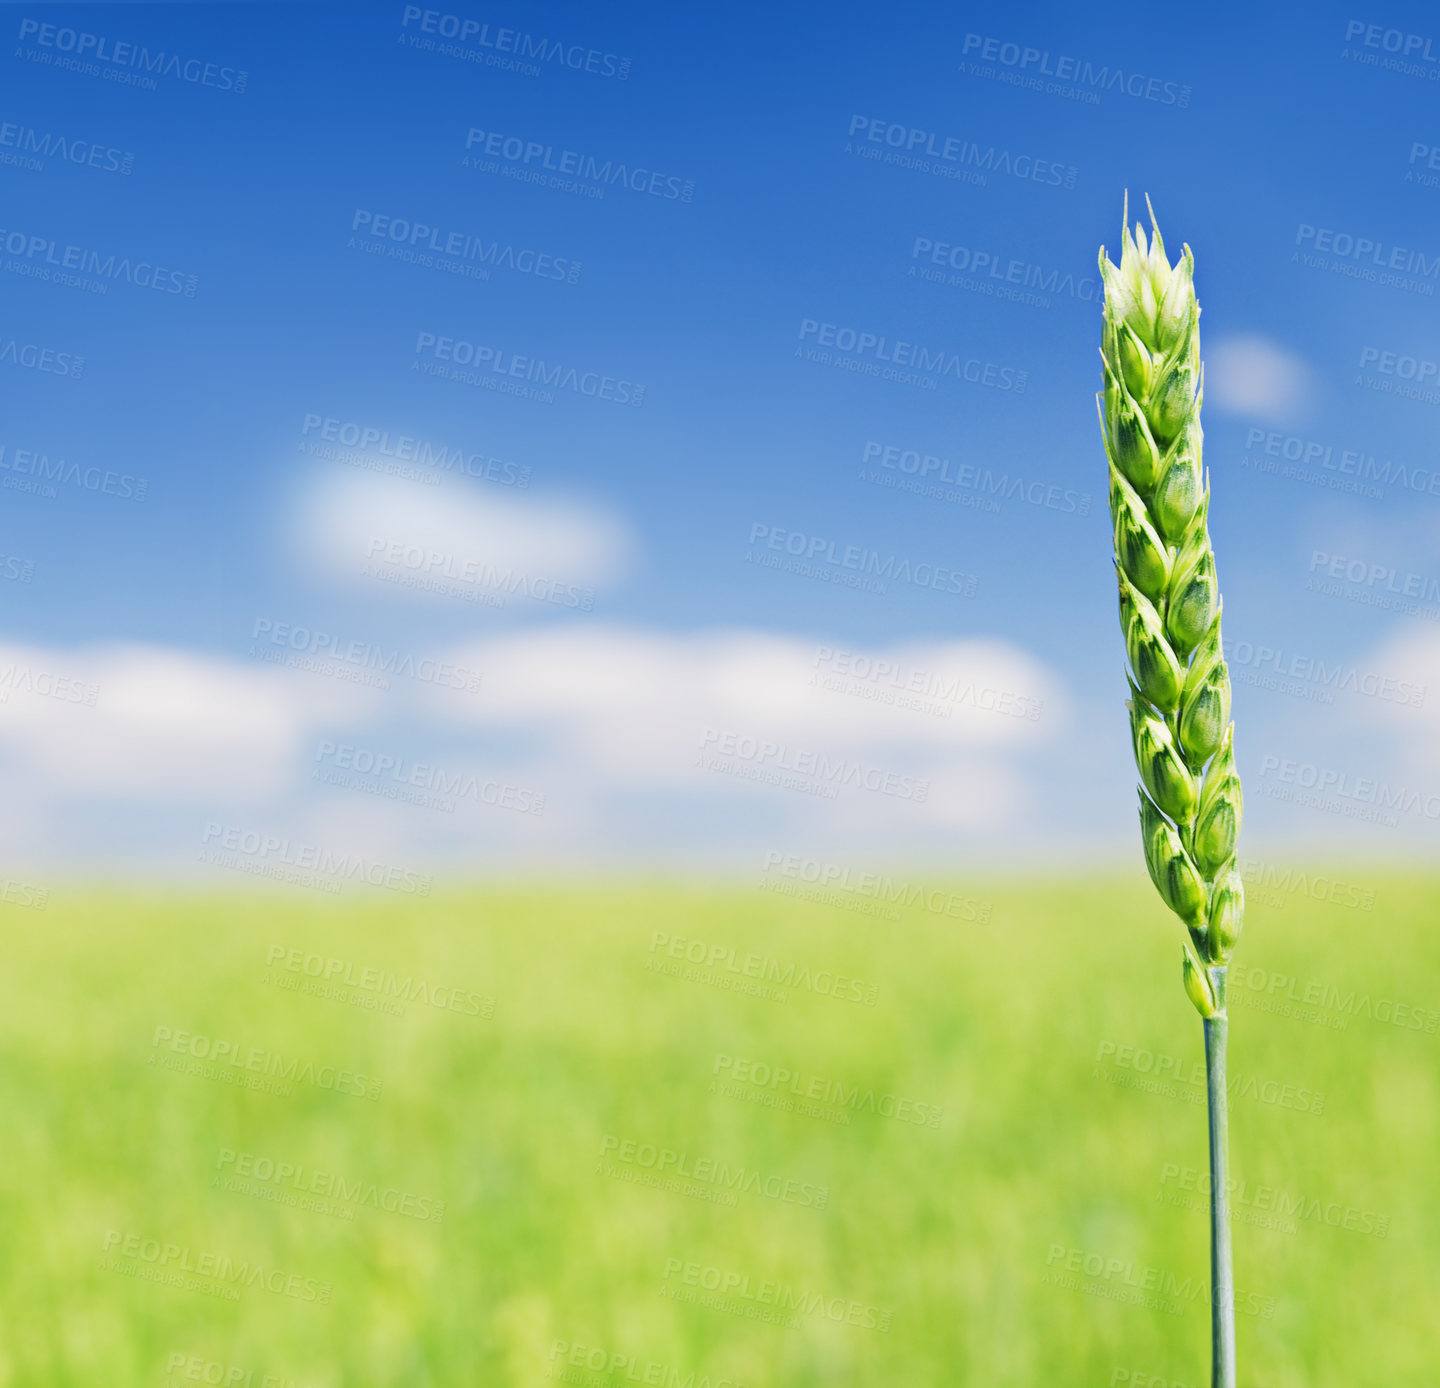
0,645 -> 372,801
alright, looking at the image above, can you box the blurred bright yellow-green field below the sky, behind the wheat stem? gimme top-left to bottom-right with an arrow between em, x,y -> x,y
0,868 -> 1440,1388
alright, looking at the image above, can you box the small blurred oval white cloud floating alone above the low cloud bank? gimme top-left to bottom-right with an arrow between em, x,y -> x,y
297,469 -> 631,598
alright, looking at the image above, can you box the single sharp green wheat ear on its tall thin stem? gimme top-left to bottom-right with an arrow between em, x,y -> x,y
1097,199 -> 1244,1388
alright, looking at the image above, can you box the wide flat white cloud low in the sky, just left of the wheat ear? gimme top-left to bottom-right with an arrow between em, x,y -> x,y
417,626 -> 1064,825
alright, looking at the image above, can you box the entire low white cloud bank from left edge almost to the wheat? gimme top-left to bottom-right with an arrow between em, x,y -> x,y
0,625 -> 1066,864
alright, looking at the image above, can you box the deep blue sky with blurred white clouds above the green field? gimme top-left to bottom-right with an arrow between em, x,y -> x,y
0,0 -> 1440,873
